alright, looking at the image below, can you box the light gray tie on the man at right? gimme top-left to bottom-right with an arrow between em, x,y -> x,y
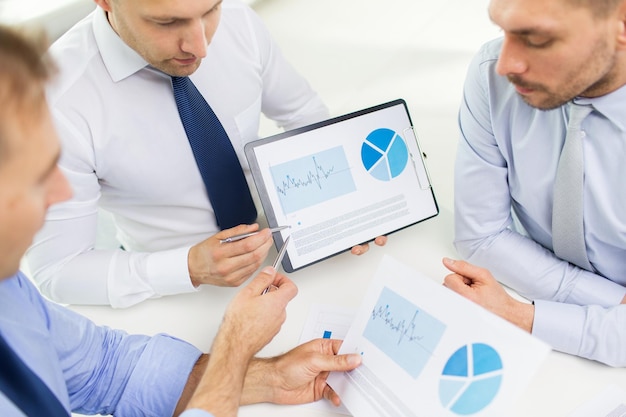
552,103 -> 593,271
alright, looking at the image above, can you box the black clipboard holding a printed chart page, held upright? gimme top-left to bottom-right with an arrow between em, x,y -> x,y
244,99 -> 439,272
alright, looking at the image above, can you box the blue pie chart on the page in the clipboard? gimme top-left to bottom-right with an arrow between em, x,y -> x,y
361,128 -> 409,181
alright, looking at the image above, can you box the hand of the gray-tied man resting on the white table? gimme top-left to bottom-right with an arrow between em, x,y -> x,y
443,258 -> 535,332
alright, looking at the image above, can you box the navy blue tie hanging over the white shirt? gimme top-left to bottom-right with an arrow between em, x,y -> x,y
172,77 -> 257,229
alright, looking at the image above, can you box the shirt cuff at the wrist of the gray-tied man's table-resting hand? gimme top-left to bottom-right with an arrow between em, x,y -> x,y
532,300 -> 585,355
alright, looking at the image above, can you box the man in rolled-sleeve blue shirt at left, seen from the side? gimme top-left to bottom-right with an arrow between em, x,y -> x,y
0,27 -> 360,417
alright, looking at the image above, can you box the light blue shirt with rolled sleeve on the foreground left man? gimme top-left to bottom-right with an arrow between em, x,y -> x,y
0,273 -> 210,417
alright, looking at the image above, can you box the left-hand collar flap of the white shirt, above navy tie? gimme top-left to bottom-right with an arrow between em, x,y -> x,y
93,7 -> 148,82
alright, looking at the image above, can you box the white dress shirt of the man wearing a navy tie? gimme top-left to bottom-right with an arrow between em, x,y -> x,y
26,0 -> 328,307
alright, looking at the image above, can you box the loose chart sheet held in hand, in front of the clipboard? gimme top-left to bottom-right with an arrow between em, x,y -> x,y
328,256 -> 550,417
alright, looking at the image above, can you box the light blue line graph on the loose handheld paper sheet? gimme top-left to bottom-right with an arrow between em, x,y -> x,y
363,287 -> 446,378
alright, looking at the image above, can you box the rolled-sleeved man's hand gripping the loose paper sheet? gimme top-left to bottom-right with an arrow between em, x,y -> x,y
241,339 -> 361,406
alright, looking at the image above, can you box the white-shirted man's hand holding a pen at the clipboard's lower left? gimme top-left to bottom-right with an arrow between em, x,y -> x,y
187,224 -> 273,287
